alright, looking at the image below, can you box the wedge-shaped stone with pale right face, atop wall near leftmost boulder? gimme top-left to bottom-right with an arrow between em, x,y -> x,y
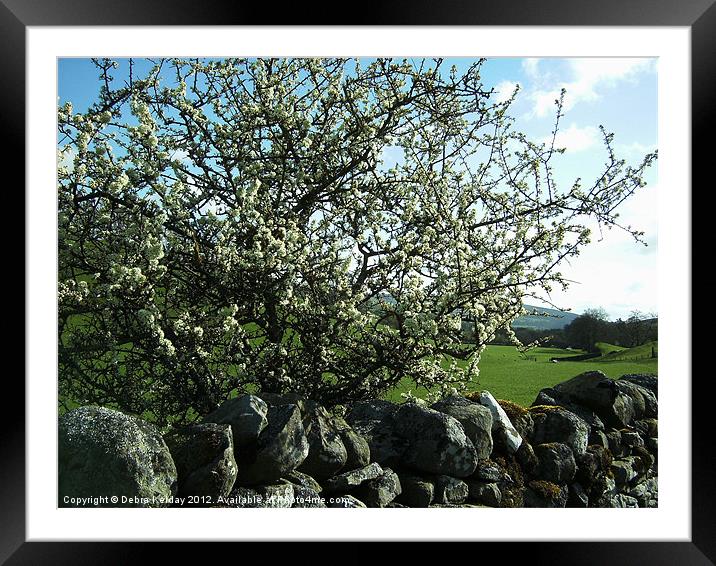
203,395 -> 268,450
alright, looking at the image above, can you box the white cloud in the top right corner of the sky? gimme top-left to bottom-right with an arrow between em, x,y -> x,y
523,57 -> 656,117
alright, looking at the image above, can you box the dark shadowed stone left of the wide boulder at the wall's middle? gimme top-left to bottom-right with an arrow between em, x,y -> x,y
346,399 -> 408,467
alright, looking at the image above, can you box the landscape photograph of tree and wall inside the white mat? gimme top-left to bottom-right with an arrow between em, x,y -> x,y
56,55 -> 660,517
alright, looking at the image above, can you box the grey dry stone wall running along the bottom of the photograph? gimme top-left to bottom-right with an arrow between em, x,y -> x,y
58,372 -> 658,508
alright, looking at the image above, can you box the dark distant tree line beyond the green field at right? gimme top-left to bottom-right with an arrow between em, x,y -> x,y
491,308 -> 658,352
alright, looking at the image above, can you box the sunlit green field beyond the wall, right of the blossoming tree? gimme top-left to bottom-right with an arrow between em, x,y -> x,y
385,344 -> 658,406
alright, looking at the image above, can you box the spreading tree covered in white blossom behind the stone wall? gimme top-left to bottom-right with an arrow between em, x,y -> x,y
58,59 -> 656,424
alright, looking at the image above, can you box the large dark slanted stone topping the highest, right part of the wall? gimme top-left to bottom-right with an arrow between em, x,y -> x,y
554,371 -> 635,428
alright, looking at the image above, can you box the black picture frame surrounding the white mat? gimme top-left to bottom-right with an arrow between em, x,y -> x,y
9,0 -> 704,565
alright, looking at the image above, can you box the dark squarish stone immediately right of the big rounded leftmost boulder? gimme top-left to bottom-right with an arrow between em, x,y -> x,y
164,423 -> 238,501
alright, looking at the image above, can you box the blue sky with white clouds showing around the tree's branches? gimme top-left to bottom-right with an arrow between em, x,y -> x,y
58,58 -> 658,319
